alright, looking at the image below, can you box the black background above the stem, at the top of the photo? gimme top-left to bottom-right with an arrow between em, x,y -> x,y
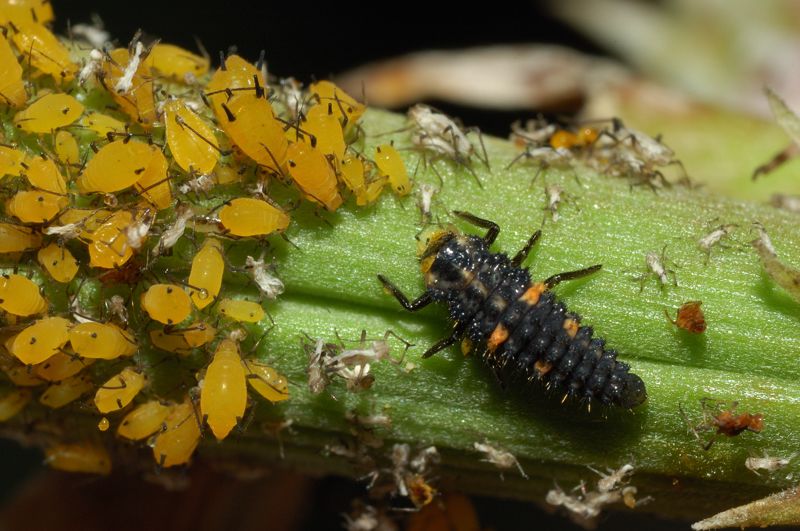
54,0 -> 607,136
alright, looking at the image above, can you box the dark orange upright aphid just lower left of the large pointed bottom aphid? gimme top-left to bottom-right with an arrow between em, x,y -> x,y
153,400 -> 200,468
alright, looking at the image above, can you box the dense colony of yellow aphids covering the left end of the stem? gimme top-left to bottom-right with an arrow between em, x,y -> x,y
0,0 -> 411,473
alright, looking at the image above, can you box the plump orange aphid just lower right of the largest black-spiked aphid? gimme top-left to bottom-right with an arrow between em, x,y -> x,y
287,142 -> 342,211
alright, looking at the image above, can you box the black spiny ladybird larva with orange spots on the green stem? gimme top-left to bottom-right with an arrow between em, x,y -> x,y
378,212 -> 647,408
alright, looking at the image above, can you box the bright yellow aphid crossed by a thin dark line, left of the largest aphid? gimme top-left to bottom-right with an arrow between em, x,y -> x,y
164,100 -> 220,174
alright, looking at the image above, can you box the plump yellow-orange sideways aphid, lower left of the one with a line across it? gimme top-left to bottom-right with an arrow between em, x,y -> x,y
78,140 -> 158,193
